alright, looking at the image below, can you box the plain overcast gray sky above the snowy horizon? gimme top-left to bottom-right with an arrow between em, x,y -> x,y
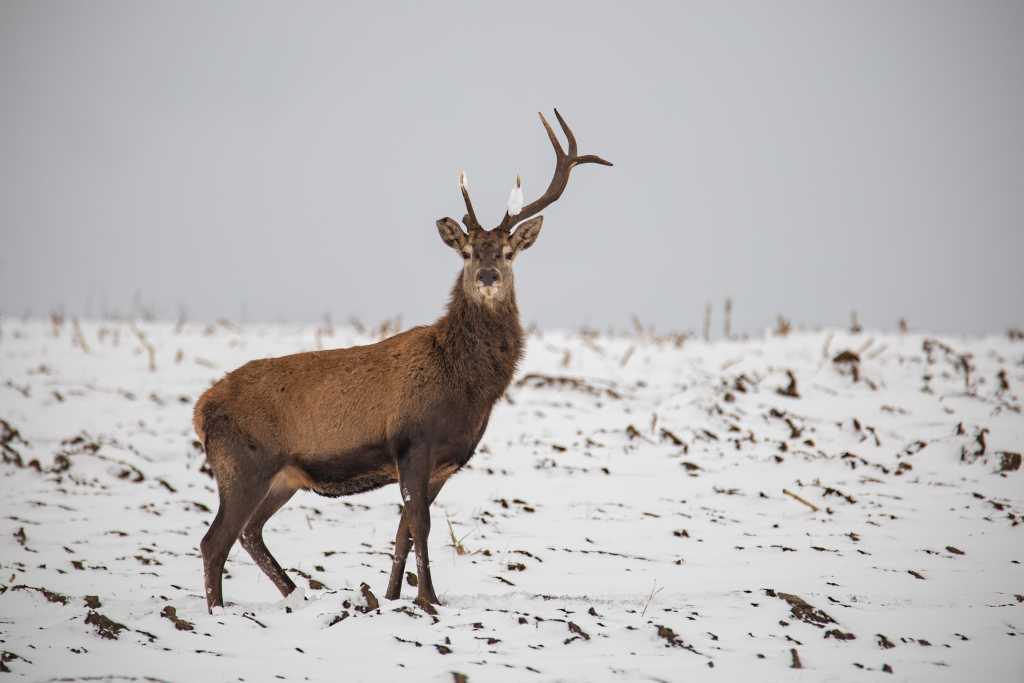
0,0 -> 1024,332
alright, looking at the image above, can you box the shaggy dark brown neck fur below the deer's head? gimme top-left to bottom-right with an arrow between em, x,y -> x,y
436,272 -> 524,402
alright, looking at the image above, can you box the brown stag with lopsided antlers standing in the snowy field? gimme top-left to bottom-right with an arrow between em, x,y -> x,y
193,110 -> 611,613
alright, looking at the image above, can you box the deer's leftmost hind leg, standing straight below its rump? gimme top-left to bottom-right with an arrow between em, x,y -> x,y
200,432 -> 272,612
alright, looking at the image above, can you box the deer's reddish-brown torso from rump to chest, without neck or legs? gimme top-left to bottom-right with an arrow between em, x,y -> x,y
194,328 -> 490,498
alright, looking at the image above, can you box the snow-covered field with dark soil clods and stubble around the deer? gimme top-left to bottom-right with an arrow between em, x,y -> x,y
0,318 -> 1024,681
